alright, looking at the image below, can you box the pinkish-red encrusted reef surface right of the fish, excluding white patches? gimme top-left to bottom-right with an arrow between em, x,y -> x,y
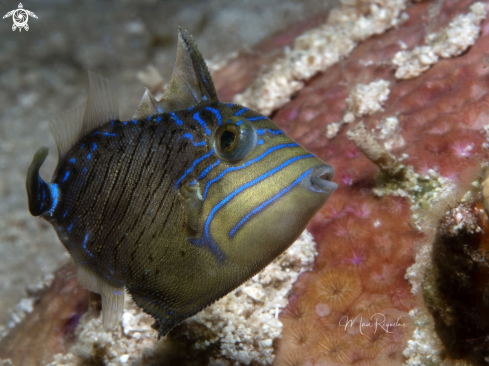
274,1 -> 489,365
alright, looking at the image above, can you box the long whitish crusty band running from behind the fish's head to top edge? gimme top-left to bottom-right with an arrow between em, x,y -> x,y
234,0 -> 406,115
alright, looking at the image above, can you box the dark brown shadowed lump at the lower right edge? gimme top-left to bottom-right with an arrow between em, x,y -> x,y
424,195 -> 489,365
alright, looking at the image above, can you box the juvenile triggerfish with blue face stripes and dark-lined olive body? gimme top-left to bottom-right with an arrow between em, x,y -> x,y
26,30 -> 336,336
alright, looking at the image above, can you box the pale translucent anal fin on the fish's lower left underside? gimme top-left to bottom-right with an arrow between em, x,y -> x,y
76,264 -> 124,330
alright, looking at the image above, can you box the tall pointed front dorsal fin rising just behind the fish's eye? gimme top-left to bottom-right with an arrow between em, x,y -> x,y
159,28 -> 217,112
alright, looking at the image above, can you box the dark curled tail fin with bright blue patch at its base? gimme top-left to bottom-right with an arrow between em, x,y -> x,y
25,147 -> 58,216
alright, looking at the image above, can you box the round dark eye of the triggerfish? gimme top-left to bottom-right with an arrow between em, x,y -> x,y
214,116 -> 256,161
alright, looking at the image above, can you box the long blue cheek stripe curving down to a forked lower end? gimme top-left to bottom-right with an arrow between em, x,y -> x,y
189,154 -> 314,263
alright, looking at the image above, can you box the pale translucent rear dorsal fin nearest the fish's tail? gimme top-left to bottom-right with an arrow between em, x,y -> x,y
49,71 -> 119,158
